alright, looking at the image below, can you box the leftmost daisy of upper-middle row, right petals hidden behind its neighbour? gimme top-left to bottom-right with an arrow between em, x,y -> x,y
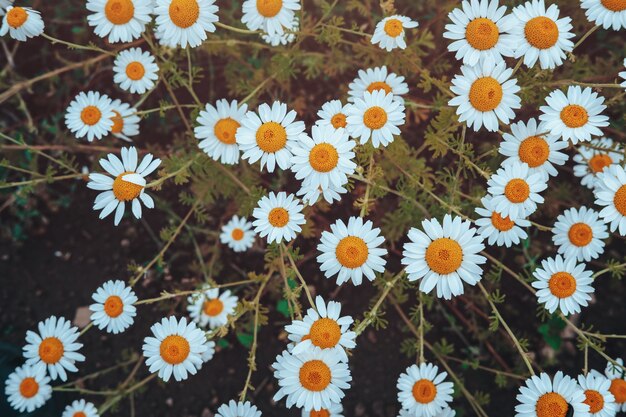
193,99 -> 248,165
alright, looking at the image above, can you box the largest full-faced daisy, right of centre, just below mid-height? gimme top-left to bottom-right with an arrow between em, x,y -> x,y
402,214 -> 487,300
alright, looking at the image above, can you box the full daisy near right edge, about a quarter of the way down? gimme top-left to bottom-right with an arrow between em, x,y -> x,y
539,85 -> 609,145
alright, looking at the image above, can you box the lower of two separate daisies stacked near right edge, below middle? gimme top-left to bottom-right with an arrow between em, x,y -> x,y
531,255 -> 593,315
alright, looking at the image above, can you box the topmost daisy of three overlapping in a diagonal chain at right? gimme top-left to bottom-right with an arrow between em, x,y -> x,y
500,119 -> 569,177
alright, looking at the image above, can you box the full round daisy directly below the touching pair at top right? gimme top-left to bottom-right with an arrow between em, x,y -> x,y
448,56 -> 521,132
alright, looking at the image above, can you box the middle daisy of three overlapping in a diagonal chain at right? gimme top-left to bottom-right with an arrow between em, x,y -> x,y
487,162 -> 548,221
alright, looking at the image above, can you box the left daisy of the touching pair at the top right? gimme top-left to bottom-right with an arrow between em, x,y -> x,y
443,0 -> 515,66
